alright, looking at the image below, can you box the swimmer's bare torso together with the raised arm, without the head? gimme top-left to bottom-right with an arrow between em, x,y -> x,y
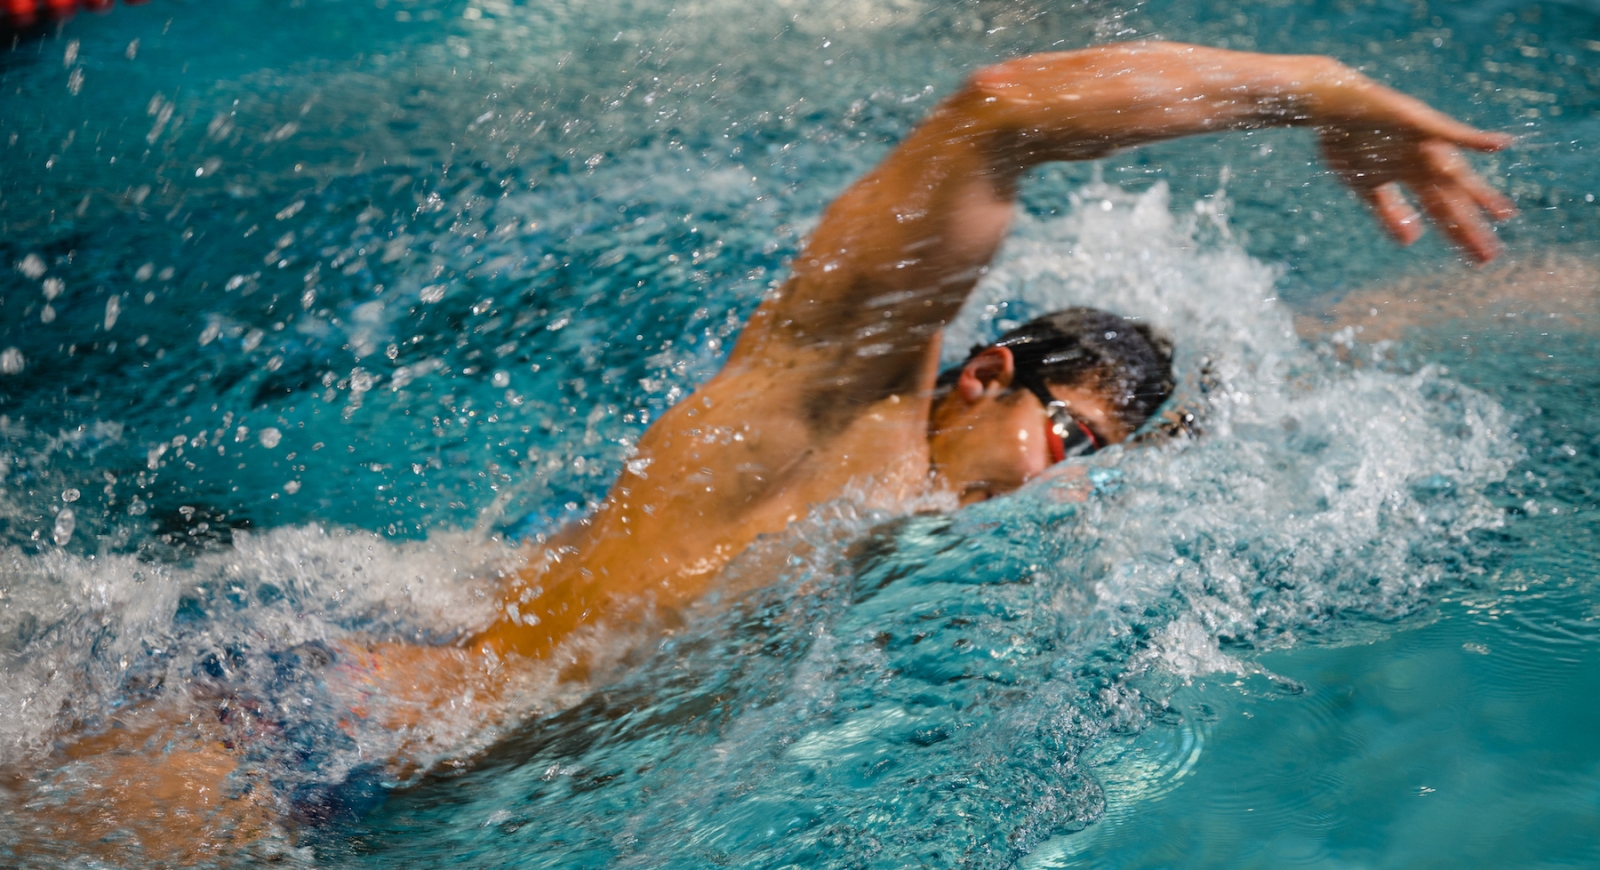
482,43 -> 1510,656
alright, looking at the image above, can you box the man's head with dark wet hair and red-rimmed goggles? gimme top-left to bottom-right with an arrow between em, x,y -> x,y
928,309 -> 1173,504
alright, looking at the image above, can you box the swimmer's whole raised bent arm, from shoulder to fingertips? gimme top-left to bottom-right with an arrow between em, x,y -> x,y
730,43 -> 1512,435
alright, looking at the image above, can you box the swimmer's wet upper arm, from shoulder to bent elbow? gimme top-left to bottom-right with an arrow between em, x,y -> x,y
728,85 -> 1014,432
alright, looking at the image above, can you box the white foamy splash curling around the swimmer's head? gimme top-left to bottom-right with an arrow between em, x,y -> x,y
946,184 -> 1522,676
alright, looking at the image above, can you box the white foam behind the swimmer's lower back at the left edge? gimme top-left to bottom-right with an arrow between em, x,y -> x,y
0,520 -> 508,763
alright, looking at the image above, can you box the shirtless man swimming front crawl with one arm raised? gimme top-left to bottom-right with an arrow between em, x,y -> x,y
9,42 -> 1514,860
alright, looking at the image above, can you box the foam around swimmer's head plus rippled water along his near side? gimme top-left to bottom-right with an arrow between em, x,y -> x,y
328,186 -> 1518,867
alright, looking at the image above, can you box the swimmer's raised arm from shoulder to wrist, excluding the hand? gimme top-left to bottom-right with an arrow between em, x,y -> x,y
728,43 -> 1320,432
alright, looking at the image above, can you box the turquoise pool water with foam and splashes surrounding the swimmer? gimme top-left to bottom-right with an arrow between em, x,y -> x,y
0,0 -> 1600,867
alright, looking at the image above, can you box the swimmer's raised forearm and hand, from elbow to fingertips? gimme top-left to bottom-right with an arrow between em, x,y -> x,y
940,42 -> 1517,262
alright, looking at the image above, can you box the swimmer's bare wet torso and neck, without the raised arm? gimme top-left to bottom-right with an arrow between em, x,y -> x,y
478,339 -> 938,657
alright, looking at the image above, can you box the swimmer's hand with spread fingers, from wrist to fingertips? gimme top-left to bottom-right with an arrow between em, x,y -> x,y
1310,64 -> 1517,262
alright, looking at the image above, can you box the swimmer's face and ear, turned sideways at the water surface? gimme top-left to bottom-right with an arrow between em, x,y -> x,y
928,347 -> 1131,504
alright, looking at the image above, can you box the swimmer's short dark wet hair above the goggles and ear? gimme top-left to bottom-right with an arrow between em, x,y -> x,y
936,309 -> 1173,429
